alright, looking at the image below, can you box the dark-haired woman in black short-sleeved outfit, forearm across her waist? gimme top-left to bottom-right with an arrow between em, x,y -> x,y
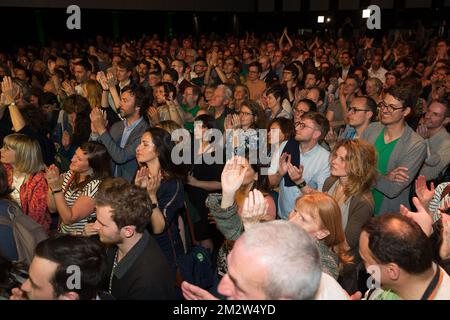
186,115 -> 224,250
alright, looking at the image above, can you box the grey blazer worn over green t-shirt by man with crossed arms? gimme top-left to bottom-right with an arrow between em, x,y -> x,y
361,122 -> 427,214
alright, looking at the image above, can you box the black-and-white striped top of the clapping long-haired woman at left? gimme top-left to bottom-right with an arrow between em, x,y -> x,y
59,171 -> 100,234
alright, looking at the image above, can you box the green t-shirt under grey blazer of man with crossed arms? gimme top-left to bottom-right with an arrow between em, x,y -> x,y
372,129 -> 400,216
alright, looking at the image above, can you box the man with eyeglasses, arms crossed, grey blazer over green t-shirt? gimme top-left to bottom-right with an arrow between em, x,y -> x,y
361,85 -> 427,215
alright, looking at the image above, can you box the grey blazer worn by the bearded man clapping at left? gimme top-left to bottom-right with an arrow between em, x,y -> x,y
97,119 -> 148,182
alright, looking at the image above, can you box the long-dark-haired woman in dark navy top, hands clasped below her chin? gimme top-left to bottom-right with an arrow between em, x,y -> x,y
134,128 -> 185,272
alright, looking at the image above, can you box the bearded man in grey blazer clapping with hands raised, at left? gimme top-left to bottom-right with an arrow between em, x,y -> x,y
91,85 -> 149,182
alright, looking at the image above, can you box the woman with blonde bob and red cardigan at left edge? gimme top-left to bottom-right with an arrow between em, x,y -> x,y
0,133 -> 51,232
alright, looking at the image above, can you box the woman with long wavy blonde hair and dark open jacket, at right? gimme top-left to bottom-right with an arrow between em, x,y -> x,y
322,139 -> 377,293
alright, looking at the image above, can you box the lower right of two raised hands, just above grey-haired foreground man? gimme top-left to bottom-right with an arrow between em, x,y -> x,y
241,189 -> 269,230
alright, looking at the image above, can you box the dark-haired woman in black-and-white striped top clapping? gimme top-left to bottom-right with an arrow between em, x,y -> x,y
45,142 -> 111,234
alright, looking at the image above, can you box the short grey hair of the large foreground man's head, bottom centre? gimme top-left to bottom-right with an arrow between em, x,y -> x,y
241,220 -> 322,300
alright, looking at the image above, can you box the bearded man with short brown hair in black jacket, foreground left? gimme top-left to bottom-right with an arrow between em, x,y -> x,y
94,178 -> 175,300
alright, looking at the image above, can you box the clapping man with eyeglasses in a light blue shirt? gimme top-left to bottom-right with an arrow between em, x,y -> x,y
269,112 -> 330,219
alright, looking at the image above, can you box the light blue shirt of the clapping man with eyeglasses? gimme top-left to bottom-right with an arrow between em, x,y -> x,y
278,144 -> 330,219
